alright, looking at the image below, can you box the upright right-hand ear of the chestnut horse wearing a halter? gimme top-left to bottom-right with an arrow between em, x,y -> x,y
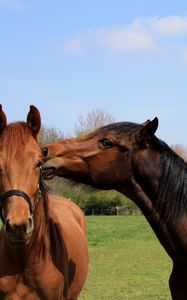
27,105 -> 41,138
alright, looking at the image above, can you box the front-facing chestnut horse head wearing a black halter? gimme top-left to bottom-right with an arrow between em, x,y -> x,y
0,105 -> 42,244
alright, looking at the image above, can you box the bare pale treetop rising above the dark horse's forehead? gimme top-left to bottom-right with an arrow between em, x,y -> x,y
75,108 -> 115,136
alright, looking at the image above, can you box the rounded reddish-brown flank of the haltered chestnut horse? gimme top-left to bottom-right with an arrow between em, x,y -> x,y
46,196 -> 89,299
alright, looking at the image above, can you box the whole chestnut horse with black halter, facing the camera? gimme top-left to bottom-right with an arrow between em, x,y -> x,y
0,106 -> 88,300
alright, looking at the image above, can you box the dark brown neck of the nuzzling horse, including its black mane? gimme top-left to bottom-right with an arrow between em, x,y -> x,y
121,147 -> 187,258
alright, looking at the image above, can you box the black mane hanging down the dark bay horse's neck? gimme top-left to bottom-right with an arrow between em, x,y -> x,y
156,146 -> 187,222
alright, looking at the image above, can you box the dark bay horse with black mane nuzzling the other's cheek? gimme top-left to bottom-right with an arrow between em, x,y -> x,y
43,118 -> 187,300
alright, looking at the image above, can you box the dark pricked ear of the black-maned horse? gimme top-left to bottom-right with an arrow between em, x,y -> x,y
136,118 -> 158,142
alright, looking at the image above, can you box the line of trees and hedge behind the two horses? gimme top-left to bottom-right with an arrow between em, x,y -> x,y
39,109 -> 187,215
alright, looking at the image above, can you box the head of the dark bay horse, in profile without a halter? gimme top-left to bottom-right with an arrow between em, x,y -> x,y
43,118 -> 158,189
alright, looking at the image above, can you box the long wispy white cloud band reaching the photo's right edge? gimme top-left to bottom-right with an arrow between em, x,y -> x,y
61,16 -> 187,62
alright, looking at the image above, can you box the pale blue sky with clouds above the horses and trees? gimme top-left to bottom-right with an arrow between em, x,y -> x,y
0,0 -> 187,146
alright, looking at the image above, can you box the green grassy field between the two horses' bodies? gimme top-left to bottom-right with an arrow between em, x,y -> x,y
79,216 -> 172,300
